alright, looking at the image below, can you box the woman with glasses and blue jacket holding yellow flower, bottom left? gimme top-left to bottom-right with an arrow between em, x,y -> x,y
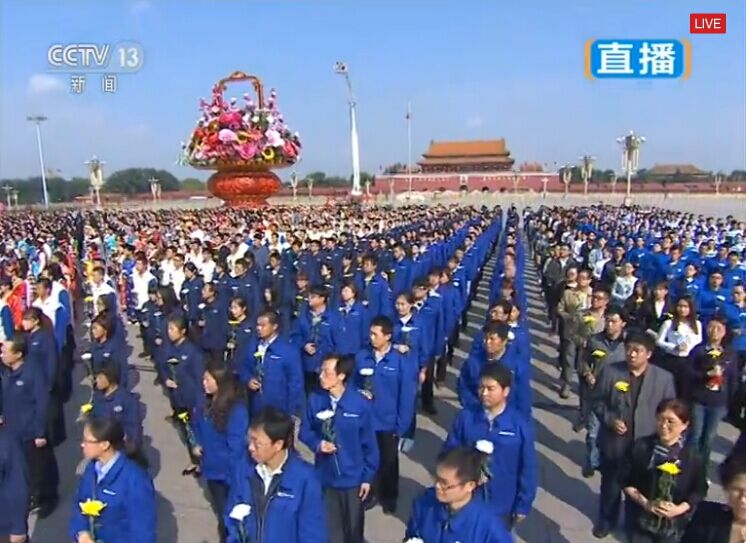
69,419 -> 156,543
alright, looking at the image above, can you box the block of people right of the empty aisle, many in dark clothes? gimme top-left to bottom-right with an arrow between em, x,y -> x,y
527,206 -> 746,543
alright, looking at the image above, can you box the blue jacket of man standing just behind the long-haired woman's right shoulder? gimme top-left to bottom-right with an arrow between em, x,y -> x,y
241,336 -> 304,415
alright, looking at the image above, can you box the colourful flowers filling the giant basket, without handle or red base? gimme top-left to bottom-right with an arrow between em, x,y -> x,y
181,84 -> 301,167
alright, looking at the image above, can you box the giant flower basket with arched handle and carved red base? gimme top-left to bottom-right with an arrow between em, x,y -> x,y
181,72 -> 301,207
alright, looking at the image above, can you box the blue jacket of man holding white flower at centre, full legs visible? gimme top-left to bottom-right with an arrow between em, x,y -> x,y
355,348 -> 417,436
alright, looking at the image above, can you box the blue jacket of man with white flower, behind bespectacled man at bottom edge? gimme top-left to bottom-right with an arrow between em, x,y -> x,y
443,406 -> 538,517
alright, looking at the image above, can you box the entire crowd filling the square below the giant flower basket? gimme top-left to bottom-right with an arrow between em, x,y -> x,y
0,205 -> 746,543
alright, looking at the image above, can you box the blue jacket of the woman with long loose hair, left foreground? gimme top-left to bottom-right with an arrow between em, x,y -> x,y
191,401 -> 249,483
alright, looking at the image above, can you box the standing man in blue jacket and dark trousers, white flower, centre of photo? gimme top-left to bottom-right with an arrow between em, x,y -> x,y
355,317 -> 417,514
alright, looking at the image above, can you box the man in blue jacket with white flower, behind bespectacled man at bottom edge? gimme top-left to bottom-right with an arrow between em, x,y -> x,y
444,362 -> 538,527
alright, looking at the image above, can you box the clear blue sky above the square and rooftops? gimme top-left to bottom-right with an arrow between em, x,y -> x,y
0,0 -> 746,183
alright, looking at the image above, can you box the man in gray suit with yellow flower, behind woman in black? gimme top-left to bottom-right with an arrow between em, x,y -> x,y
593,334 -> 676,538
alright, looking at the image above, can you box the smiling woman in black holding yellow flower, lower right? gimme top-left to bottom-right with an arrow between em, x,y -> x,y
624,399 -> 707,543
